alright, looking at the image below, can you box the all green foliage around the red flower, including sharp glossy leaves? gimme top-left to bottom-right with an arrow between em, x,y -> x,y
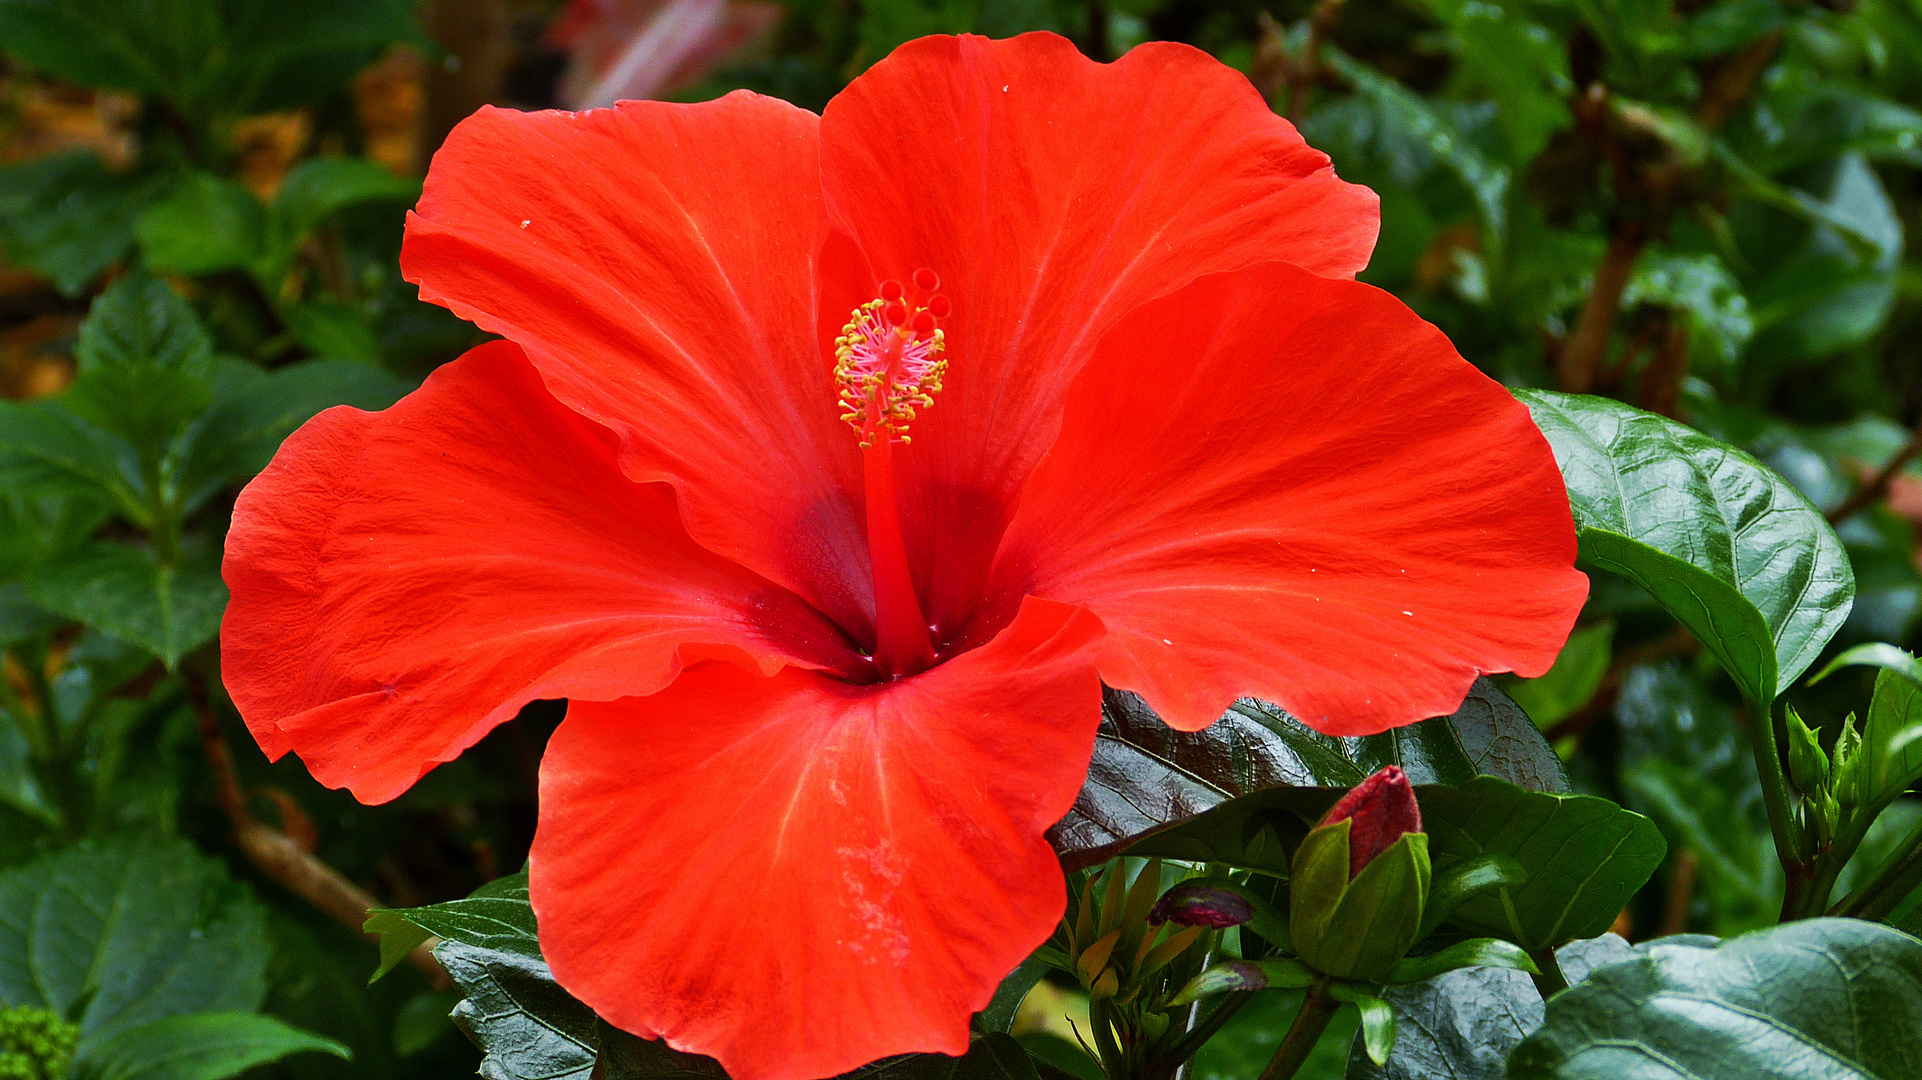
0,0 -> 1922,1078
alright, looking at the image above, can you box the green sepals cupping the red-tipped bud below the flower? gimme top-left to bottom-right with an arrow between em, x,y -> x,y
1294,822 -> 1432,982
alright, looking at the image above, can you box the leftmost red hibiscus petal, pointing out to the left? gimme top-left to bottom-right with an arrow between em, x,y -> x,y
221,342 -> 851,803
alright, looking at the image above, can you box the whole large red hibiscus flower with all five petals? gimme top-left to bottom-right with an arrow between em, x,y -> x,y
221,35 -> 1586,1080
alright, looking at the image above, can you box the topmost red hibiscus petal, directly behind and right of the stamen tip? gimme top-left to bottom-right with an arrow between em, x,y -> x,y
821,35 -> 1380,626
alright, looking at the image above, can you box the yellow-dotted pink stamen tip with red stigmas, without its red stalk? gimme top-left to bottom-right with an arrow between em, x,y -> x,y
834,269 -> 953,450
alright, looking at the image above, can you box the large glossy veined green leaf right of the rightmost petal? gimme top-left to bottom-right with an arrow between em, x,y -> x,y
1516,390 -> 1855,707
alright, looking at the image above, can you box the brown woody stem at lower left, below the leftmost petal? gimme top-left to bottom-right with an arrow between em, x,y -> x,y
196,694 -> 452,990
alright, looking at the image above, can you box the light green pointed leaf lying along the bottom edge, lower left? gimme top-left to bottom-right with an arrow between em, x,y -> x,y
73,1013 -> 352,1080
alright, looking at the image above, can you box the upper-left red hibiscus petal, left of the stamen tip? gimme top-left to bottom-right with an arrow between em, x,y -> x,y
402,92 -> 873,630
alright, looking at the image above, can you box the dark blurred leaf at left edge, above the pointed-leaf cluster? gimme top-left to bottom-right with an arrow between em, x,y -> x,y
0,151 -> 158,296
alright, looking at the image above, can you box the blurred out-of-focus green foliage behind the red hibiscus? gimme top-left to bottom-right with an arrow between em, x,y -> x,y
0,0 -> 1922,1078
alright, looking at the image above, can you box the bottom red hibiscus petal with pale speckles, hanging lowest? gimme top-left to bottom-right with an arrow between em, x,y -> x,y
530,600 -> 1101,1080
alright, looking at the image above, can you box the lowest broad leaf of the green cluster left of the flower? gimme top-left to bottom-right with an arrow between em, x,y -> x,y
33,542 -> 227,669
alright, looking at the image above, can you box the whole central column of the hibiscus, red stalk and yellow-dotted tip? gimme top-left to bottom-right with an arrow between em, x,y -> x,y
834,269 -> 953,678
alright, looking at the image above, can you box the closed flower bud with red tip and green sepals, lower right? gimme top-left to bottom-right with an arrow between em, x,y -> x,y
1288,765 -> 1432,982
